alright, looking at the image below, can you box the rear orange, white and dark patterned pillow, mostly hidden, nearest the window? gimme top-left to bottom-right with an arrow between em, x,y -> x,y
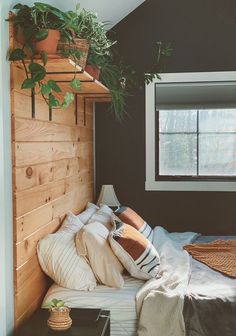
115,206 -> 153,243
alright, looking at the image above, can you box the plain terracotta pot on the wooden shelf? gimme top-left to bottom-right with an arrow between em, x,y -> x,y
35,29 -> 60,56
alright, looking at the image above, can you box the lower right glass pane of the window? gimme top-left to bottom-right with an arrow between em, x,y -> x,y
199,134 -> 236,176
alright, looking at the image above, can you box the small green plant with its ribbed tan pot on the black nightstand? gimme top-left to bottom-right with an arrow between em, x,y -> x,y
45,299 -> 72,330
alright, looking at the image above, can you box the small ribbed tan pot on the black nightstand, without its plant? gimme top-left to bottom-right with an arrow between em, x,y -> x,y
47,307 -> 72,330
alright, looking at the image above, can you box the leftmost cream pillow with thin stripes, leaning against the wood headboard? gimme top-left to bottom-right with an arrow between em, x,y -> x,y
37,213 -> 96,290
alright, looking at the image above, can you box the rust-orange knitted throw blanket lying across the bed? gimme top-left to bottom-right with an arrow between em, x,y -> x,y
184,240 -> 236,278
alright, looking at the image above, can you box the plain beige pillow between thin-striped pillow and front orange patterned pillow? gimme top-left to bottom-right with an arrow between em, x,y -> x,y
76,222 -> 124,288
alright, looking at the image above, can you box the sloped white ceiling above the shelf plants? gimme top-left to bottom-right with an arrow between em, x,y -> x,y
14,0 -> 145,28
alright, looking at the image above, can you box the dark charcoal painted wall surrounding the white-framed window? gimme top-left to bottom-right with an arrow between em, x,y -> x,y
96,0 -> 236,234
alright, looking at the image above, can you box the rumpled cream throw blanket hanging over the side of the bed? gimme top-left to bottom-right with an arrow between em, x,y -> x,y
136,227 -> 197,336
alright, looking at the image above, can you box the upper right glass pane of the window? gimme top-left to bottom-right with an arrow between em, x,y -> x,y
199,109 -> 236,132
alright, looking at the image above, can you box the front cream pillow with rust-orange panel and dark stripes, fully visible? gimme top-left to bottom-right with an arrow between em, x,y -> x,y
109,221 -> 160,280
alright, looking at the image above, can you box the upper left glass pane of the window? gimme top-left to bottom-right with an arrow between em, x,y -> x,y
159,110 -> 197,133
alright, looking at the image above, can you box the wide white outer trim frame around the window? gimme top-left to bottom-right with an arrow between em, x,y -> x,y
145,71 -> 236,191
